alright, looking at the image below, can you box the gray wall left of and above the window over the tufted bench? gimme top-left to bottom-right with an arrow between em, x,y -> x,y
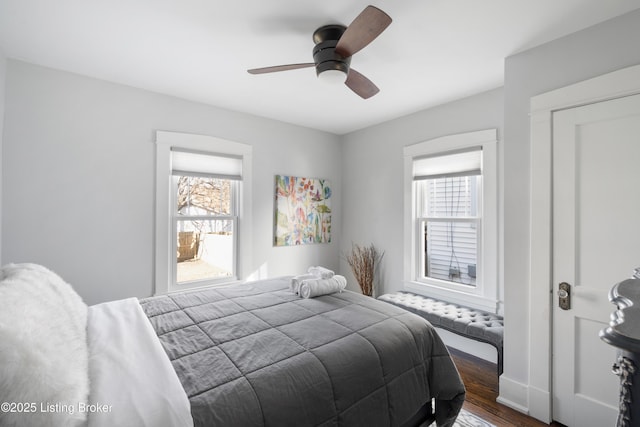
341,89 -> 503,294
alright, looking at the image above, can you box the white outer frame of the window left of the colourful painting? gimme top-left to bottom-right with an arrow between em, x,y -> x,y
154,131 -> 253,295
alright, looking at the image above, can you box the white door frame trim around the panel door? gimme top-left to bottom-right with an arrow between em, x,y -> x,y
528,65 -> 640,423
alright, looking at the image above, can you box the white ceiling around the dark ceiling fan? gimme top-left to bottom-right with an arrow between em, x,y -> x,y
0,0 -> 640,134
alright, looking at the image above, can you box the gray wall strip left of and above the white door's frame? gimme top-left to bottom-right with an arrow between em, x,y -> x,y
504,6 -> 640,405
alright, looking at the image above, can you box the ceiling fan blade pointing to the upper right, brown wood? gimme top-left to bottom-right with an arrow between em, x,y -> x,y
336,6 -> 391,58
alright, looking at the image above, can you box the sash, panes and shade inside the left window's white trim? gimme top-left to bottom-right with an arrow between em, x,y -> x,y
171,148 -> 242,284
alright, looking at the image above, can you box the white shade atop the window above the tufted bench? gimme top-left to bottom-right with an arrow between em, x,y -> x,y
413,147 -> 482,181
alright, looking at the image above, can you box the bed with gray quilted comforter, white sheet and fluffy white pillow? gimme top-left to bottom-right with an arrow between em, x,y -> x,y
0,265 -> 464,427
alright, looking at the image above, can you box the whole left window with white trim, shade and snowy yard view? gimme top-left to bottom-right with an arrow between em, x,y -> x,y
155,131 -> 251,294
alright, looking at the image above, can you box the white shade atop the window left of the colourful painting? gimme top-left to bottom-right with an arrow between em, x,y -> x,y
171,148 -> 242,181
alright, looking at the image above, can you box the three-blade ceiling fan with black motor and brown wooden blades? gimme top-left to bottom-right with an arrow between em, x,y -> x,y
247,6 -> 391,99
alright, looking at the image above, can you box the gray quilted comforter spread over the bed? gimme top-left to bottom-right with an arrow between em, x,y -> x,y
140,278 -> 464,427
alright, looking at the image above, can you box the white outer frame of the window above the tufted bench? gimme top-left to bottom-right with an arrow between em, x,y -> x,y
403,129 -> 498,313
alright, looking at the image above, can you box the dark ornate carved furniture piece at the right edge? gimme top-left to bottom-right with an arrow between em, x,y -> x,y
600,269 -> 640,427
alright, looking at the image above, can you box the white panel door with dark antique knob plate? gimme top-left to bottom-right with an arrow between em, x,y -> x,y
552,95 -> 640,427
